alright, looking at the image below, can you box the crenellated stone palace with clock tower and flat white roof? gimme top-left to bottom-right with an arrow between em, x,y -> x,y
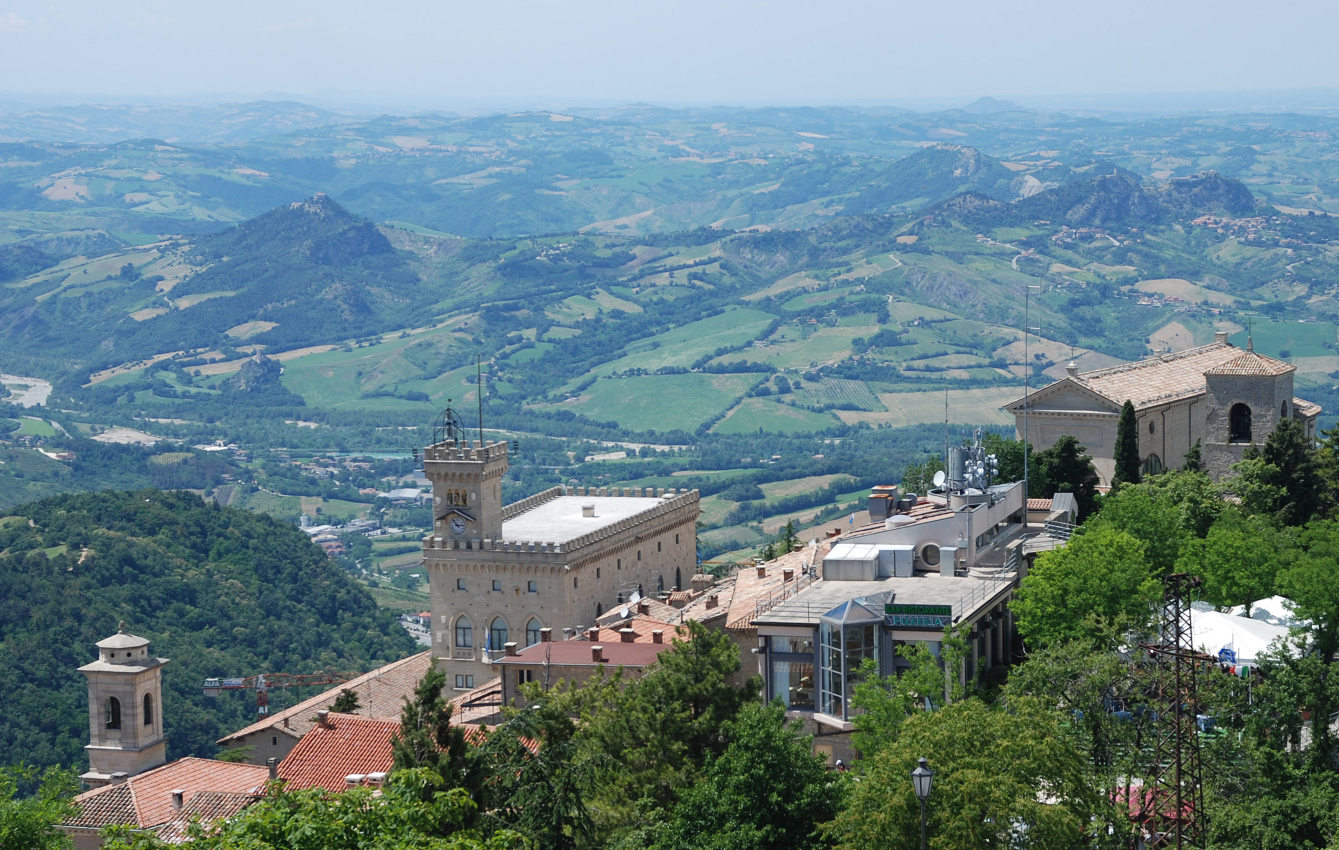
423,422 -> 700,691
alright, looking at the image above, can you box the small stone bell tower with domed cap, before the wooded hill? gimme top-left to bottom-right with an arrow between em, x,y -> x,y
79,622 -> 167,788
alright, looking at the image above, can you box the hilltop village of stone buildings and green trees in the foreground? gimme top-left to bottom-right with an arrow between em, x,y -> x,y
33,337 -> 1339,847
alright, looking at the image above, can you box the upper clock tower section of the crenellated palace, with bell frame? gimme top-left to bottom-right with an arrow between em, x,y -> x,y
423,408 -> 510,539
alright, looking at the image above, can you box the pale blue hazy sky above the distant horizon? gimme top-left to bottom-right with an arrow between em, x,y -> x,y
0,0 -> 1339,107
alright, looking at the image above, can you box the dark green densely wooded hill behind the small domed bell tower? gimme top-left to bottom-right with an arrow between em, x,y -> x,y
0,490 -> 414,767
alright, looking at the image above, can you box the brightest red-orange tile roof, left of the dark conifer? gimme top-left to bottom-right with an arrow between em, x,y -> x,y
271,712 -> 400,791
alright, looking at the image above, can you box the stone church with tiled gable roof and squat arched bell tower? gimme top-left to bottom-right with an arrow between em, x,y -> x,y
1004,332 -> 1320,486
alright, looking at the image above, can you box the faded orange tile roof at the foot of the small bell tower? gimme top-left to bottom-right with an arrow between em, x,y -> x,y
64,758 -> 269,829
